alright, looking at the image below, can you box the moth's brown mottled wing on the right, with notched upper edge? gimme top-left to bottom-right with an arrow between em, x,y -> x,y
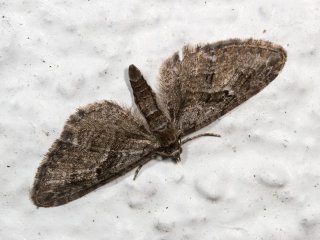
160,39 -> 287,136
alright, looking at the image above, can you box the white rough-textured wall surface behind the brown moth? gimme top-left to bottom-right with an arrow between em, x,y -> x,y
0,0 -> 320,240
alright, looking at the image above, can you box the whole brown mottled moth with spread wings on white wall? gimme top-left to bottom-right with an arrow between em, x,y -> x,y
31,39 -> 287,207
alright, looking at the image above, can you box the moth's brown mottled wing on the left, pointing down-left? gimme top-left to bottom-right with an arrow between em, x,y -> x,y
31,101 -> 158,207
